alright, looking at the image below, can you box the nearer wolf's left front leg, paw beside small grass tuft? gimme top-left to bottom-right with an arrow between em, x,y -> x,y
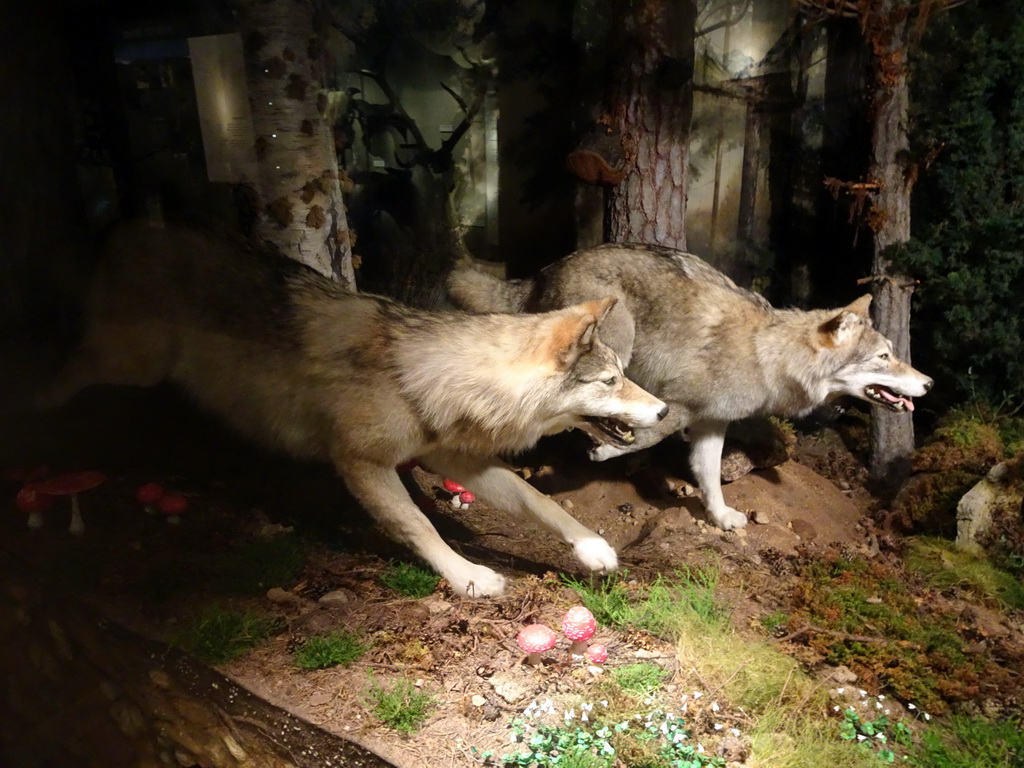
338,460 -> 505,597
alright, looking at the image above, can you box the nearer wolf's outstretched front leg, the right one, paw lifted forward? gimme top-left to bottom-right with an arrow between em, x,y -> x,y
421,453 -> 618,573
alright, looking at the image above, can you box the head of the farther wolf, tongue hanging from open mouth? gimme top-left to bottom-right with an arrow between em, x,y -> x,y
816,296 -> 934,412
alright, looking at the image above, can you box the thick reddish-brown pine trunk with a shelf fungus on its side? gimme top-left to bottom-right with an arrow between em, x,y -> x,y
608,0 -> 696,250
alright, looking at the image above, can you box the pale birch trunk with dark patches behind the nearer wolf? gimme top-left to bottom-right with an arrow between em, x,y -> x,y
240,0 -> 355,290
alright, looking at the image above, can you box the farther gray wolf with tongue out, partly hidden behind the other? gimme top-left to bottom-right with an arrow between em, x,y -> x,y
449,245 -> 933,530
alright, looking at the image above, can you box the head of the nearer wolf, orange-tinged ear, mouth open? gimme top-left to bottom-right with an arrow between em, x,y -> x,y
546,297 -> 668,445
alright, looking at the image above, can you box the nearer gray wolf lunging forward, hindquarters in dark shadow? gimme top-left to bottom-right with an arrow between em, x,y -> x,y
39,224 -> 668,596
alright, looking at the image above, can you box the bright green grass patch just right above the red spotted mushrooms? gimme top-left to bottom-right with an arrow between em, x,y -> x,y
563,568 -> 727,639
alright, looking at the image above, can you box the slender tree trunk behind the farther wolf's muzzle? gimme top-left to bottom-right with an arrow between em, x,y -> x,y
867,0 -> 914,483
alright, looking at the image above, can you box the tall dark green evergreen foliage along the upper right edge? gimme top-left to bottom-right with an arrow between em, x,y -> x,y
892,0 -> 1024,403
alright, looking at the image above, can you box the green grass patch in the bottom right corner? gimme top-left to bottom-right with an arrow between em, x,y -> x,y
911,715 -> 1024,768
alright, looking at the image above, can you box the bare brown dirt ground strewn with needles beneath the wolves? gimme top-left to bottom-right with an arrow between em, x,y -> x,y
0,390 -> 1015,766
